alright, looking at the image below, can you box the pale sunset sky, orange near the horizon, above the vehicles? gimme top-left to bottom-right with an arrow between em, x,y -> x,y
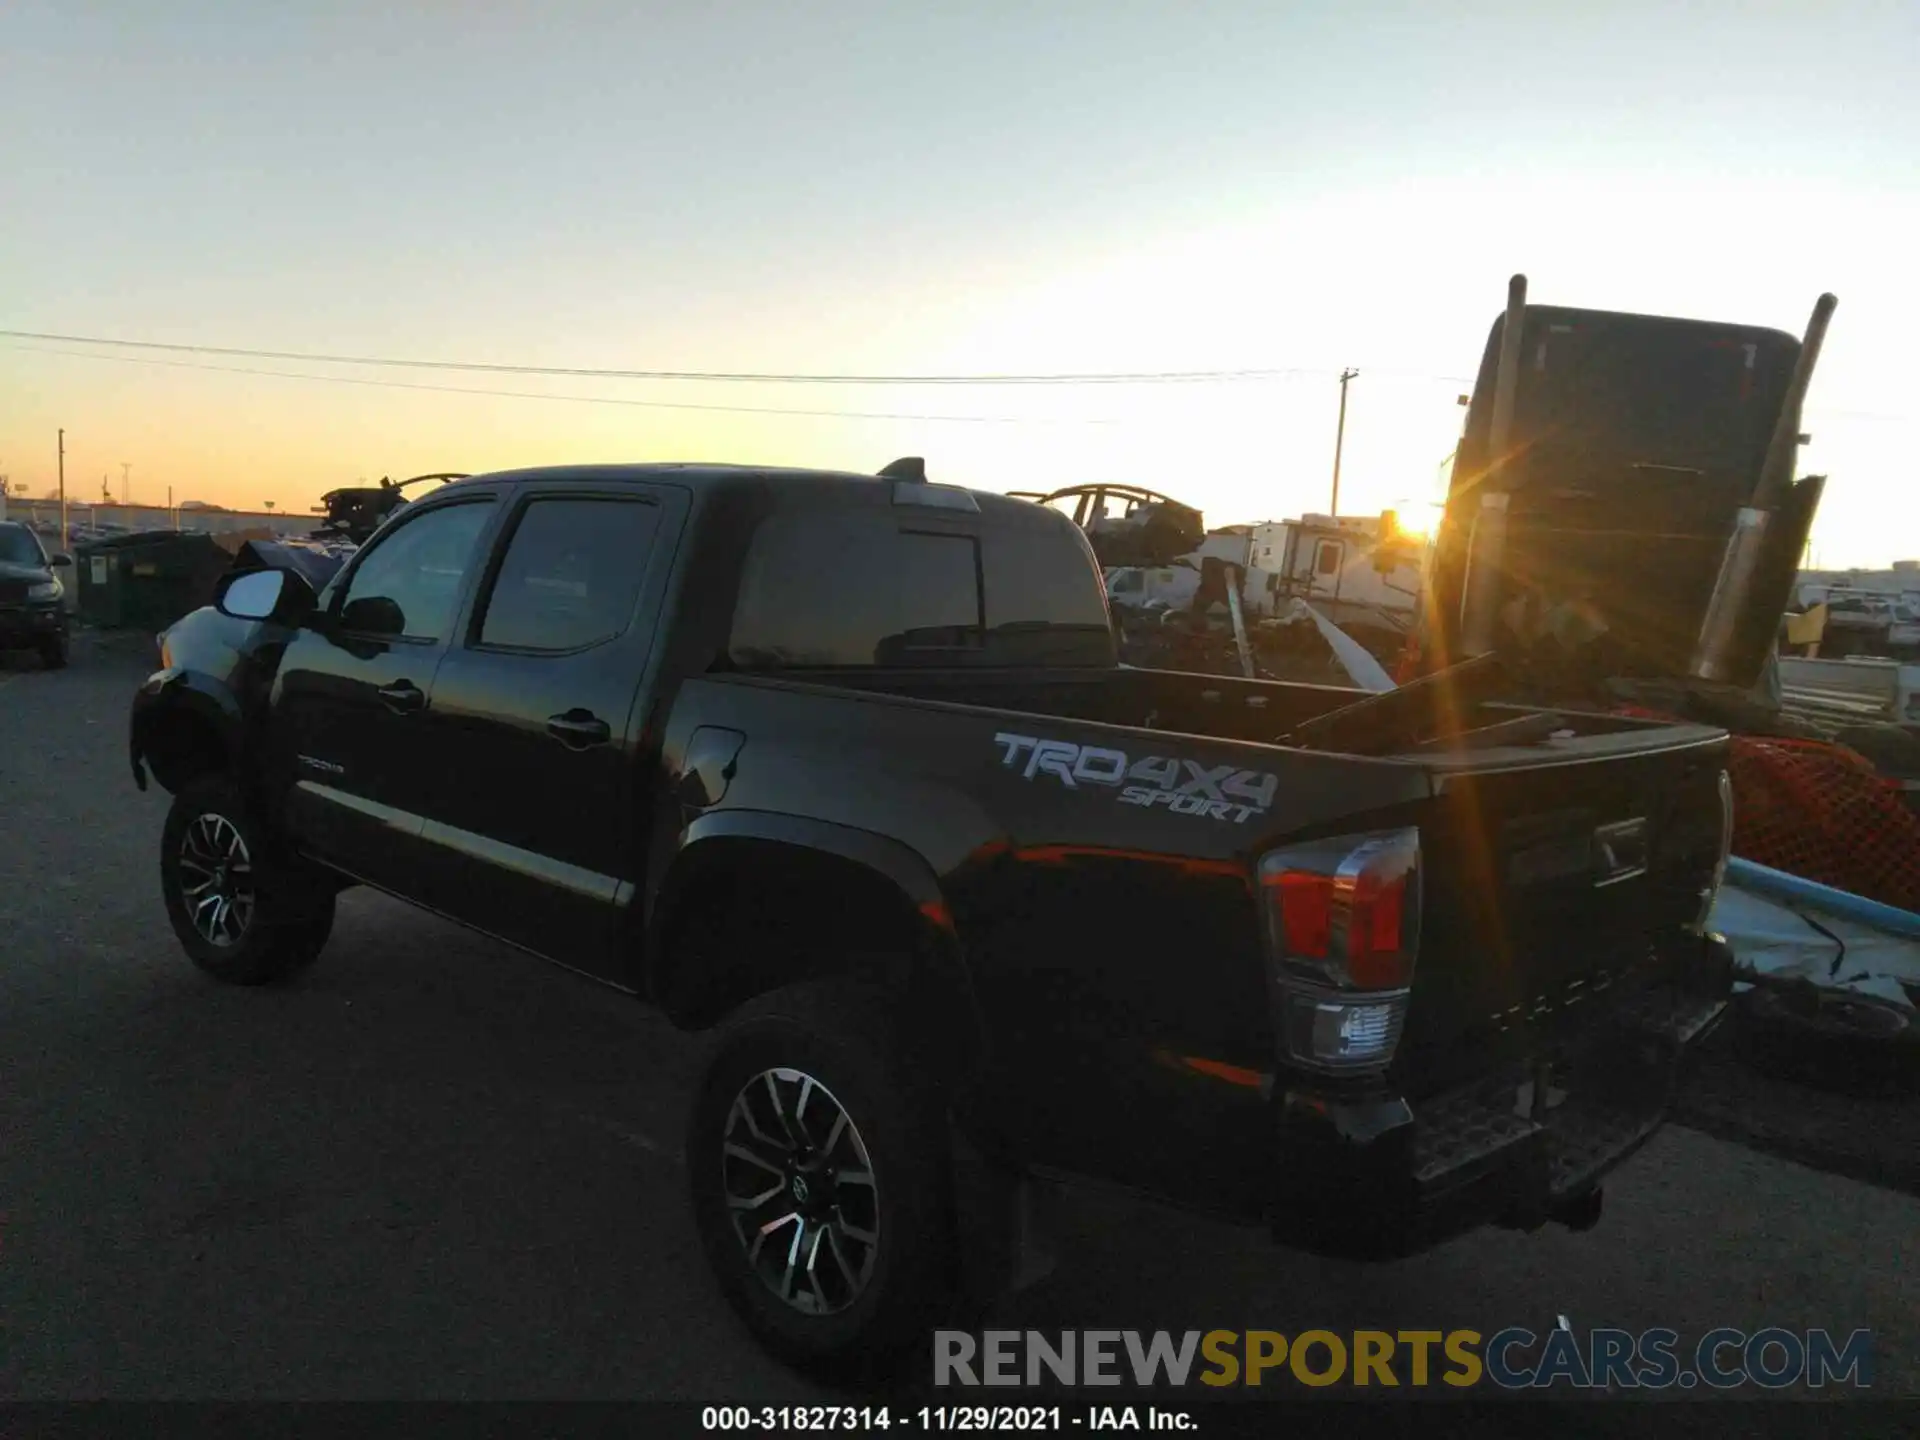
0,0 -> 1920,564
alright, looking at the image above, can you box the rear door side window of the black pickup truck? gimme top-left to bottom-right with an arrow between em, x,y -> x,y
480,497 -> 660,651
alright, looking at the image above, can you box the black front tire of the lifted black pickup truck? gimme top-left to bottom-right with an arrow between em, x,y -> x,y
159,776 -> 334,985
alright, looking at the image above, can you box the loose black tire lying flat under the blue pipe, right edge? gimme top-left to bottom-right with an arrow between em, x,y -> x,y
1734,983 -> 1920,1094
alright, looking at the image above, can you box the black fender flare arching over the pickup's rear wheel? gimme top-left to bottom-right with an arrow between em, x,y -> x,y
637,810 -> 985,1066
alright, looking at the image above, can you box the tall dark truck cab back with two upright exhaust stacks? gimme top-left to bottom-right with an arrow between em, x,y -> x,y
1419,276 -> 1836,710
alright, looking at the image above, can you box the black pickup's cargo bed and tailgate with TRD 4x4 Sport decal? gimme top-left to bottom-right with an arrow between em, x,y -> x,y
675,670 -> 1726,1148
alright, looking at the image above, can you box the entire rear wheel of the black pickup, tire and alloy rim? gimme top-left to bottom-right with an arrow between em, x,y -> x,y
687,985 -> 956,1377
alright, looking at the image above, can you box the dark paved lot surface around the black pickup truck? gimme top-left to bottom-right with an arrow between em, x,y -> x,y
0,636 -> 1920,1404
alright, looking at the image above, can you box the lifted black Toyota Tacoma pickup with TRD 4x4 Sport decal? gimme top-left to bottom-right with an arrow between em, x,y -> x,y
131,463 -> 1730,1367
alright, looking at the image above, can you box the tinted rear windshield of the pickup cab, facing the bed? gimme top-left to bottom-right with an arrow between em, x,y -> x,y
728,511 -> 1114,670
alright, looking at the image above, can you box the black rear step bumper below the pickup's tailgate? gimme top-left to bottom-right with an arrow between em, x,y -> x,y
1269,939 -> 1732,1260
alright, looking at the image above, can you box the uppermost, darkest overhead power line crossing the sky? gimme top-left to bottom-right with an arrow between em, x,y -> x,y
0,330 -> 1465,386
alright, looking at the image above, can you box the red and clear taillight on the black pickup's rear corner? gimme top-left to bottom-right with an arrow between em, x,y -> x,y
1260,829 -> 1421,1069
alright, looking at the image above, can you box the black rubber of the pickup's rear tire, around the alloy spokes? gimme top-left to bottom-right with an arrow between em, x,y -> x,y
685,983 -> 958,1380
